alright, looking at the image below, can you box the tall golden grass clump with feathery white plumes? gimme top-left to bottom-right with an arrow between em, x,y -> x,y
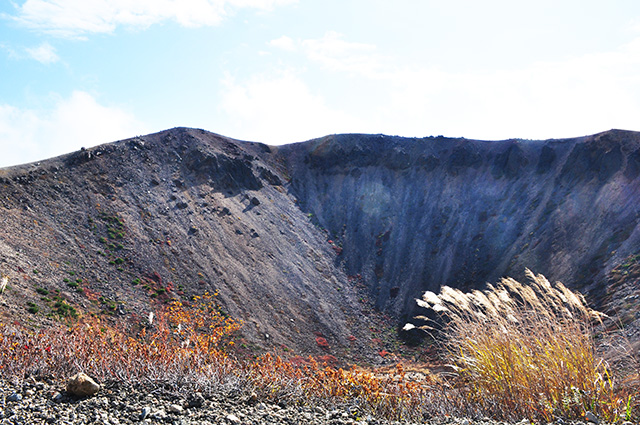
418,270 -> 638,422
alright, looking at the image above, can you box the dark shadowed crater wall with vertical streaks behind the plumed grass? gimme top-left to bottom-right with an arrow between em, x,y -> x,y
278,130 -> 640,319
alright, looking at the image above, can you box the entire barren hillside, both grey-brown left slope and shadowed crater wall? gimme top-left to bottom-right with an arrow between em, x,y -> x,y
0,128 -> 640,360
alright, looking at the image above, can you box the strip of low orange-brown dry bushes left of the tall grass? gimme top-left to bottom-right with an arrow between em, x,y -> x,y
0,295 -> 460,420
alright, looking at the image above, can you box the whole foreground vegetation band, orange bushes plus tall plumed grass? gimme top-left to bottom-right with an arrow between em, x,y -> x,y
0,273 -> 640,422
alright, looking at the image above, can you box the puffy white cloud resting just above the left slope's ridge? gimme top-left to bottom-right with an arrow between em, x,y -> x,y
0,91 -> 146,167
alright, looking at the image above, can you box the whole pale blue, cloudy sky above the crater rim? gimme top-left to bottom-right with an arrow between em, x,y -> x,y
0,0 -> 640,167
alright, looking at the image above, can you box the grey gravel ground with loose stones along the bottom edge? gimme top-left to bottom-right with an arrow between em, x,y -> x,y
0,379 -> 616,425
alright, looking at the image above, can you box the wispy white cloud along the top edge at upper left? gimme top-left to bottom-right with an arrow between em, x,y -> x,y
13,0 -> 297,38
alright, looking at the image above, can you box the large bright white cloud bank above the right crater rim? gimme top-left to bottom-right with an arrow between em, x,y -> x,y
262,32 -> 640,139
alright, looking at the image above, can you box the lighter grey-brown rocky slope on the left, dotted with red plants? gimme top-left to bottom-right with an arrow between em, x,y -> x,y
0,129 -> 374,358
